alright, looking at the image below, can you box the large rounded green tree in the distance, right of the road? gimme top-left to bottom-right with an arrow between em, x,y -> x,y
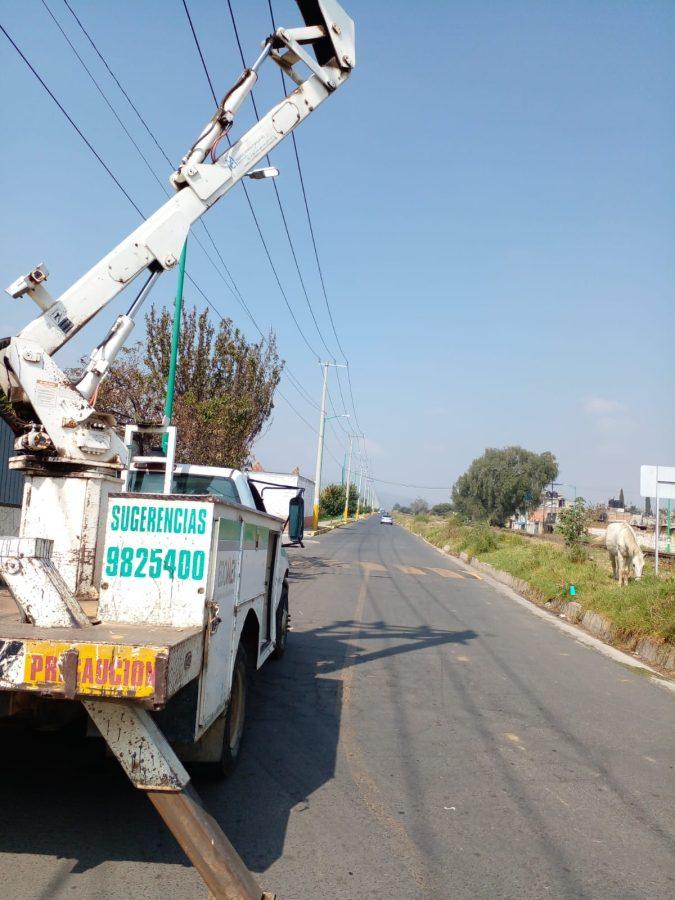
452,447 -> 558,525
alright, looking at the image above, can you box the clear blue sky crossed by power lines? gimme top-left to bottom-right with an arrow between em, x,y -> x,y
0,0 -> 675,503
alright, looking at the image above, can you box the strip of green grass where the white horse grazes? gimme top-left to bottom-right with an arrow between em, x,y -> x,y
399,516 -> 675,643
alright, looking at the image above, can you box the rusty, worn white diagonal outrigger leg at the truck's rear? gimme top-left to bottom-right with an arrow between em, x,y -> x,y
0,537 -> 275,900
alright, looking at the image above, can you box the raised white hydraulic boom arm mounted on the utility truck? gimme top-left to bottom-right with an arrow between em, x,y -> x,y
0,0 -> 355,466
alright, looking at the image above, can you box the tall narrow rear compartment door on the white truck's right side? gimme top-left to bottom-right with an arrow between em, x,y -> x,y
197,507 -> 244,736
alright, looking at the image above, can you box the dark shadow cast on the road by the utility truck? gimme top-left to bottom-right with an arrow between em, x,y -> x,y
0,620 -> 477,884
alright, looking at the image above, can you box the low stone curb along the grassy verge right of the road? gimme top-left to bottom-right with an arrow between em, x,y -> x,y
402,525 -> 675,677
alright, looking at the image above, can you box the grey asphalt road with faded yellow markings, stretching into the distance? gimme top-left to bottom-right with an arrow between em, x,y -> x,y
0,519 -> 675,900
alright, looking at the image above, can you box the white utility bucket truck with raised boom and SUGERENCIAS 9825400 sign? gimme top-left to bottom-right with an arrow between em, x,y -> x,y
0,0 -> 355,898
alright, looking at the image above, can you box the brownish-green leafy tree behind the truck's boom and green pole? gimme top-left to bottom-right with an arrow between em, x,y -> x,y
88,306 -> 283,468
